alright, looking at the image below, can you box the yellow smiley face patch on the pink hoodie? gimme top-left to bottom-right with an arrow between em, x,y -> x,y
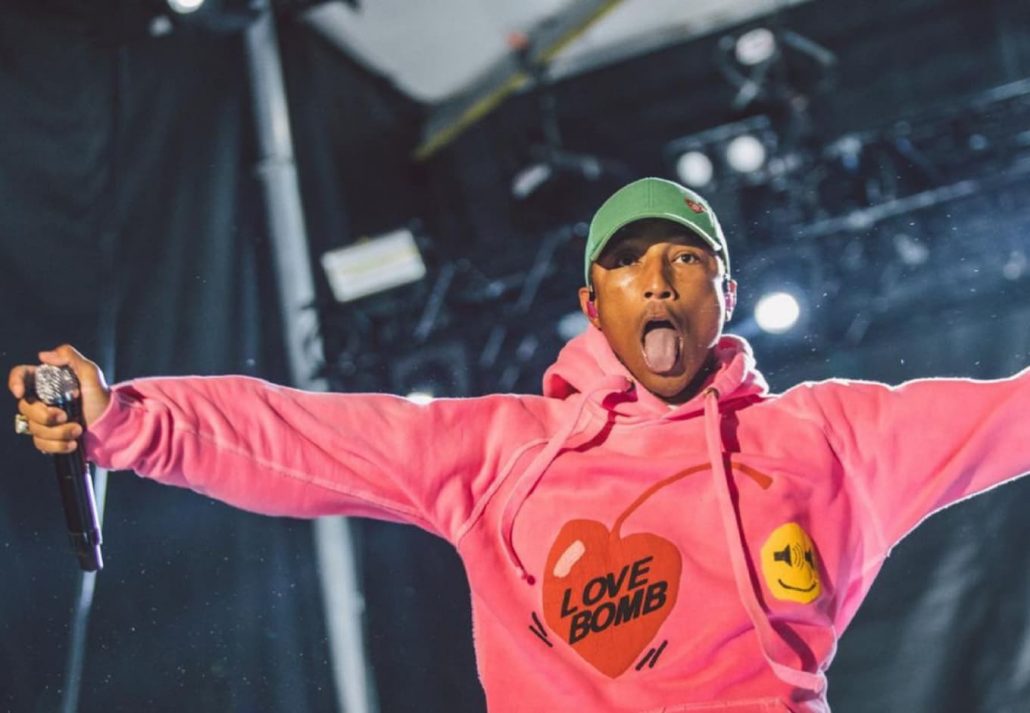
762,522 -> 823,604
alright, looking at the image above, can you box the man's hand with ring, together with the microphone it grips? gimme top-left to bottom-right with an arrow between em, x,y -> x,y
7,345 -> 110,571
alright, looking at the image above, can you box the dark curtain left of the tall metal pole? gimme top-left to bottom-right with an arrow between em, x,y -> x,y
0,2 -> 335,712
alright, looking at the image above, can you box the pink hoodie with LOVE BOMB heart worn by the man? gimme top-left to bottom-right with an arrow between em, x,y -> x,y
87,330 -> 1030,713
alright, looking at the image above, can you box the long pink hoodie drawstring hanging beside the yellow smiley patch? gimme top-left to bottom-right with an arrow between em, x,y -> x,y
705,387 -> 826,693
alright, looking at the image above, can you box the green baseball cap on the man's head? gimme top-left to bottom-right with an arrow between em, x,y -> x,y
584,177 -> 729,287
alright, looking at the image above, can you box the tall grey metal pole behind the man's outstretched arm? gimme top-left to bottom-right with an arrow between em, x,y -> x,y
246,8 -> 373,713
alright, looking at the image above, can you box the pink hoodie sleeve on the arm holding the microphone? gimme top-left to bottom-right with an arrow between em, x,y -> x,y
85,376 -> 542,539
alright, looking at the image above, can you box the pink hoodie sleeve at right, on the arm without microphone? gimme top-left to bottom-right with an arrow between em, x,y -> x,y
814,369 -> 1030,549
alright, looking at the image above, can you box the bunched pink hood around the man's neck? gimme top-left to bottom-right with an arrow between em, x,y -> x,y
544,327 -> 768,417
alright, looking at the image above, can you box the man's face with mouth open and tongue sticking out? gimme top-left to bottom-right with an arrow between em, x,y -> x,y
580,218 -> 736,403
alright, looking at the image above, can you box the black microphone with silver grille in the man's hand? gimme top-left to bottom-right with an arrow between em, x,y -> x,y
34,365 -> 104,572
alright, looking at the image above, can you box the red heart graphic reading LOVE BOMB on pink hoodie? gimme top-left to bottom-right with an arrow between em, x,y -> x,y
544,518 -> 682,678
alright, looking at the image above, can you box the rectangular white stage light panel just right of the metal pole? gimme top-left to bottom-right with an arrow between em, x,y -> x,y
321,229 -> 425,302
